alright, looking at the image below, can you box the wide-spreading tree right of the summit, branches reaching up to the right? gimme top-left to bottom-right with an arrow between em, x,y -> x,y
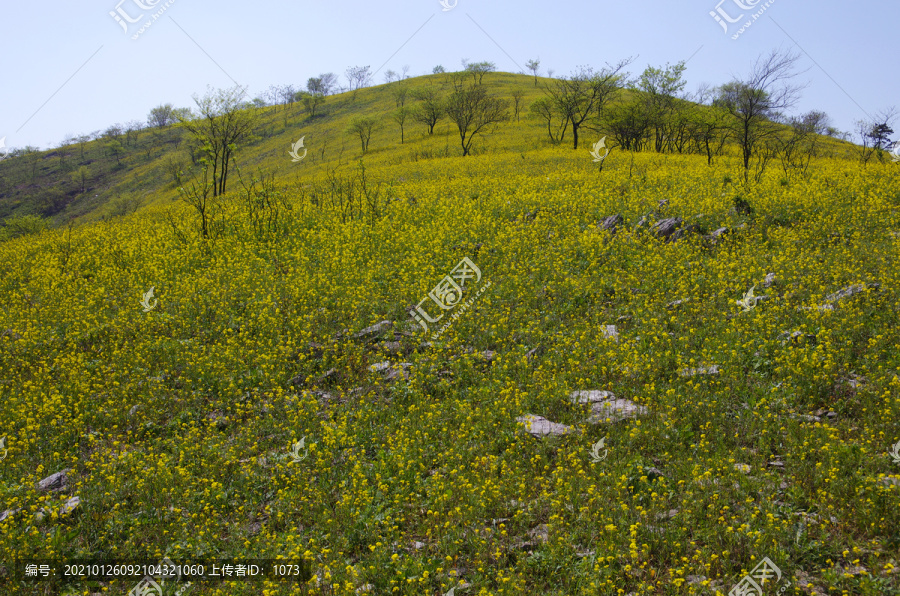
546,58 -> 632,149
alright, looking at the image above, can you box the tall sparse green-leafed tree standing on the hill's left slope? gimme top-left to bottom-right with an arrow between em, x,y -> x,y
180,86 -> 256,197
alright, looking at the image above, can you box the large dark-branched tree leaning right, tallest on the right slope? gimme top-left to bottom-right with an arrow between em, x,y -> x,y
715,50 -> 803,173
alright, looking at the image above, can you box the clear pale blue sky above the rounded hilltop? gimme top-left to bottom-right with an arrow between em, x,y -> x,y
0,0 -> 900,149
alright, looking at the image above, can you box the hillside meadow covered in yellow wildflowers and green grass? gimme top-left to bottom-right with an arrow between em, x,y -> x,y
0,73 -> 900,596
